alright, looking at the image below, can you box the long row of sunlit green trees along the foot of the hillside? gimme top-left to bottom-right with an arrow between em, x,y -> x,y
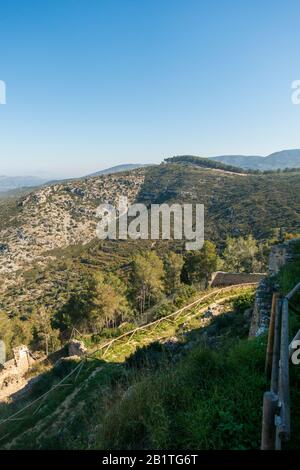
0,235 -> 265,354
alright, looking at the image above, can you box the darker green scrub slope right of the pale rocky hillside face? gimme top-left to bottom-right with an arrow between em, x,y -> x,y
138,163 -> 300,243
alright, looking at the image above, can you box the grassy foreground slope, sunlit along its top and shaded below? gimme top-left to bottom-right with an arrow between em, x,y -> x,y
0,287 -> 265,449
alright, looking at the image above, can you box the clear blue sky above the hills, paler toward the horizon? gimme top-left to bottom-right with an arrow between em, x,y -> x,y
0,0 -> 300,176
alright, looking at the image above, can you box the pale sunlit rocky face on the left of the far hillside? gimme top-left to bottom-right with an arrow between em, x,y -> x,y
0,170 -> 144,282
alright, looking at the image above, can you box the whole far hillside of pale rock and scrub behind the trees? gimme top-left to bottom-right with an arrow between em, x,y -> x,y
0,163 -> 300,318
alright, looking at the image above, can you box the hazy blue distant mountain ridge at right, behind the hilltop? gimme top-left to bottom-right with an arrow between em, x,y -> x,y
210,149 -> 300,171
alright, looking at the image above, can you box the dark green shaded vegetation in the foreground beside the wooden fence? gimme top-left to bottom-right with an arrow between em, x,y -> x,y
96,339 -> 265,450
